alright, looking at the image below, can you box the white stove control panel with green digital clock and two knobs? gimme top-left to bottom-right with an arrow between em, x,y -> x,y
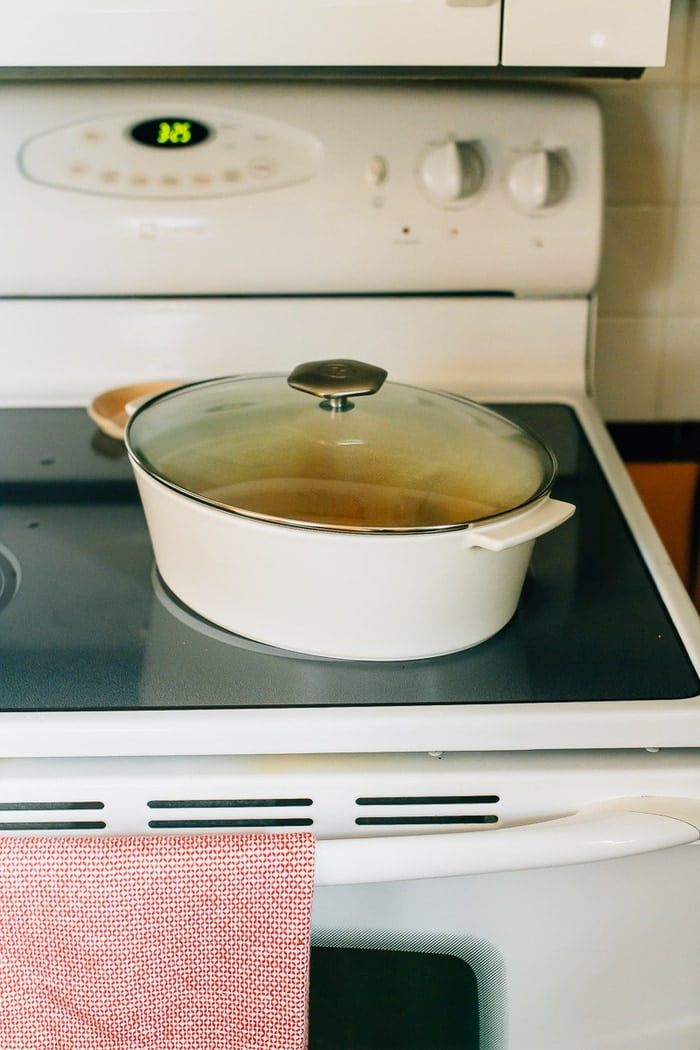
0,80 -> 602,298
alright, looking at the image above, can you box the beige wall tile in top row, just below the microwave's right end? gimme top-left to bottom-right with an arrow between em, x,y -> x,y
593,83 -> 683,205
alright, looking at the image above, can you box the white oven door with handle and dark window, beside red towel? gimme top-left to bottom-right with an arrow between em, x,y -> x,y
310,800 -> 700,1050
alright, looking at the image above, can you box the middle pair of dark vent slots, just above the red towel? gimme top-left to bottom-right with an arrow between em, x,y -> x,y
147,798 -> 314,828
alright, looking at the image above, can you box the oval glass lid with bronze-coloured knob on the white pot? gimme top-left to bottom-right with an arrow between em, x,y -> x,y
126,360 -> 556,532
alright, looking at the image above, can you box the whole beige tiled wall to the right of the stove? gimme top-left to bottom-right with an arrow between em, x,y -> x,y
587,0 -> 700,421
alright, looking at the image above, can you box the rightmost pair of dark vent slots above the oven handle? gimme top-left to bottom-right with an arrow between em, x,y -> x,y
355,795 -> 501,827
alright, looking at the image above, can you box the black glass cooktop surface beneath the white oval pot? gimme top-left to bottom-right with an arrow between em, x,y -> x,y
0,404 -> 700,711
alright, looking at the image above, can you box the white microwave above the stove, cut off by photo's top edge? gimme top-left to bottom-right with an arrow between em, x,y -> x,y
0,0 -> 671,70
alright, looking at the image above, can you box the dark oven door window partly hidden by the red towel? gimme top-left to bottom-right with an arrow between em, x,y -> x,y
309,946 -> 487,1050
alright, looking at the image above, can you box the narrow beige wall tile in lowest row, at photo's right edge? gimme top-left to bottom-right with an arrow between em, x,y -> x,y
659,317 -> 700,421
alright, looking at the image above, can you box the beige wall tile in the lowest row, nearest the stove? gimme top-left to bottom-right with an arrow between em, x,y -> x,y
594,317 -> 664,421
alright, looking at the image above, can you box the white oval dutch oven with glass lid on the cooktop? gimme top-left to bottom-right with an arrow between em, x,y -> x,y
125,360 -> 574,660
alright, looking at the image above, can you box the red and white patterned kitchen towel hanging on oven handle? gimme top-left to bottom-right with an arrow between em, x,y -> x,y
0,832 -> 314,1050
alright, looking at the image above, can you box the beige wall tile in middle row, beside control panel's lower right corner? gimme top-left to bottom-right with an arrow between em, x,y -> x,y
598,205 -> 671,317
